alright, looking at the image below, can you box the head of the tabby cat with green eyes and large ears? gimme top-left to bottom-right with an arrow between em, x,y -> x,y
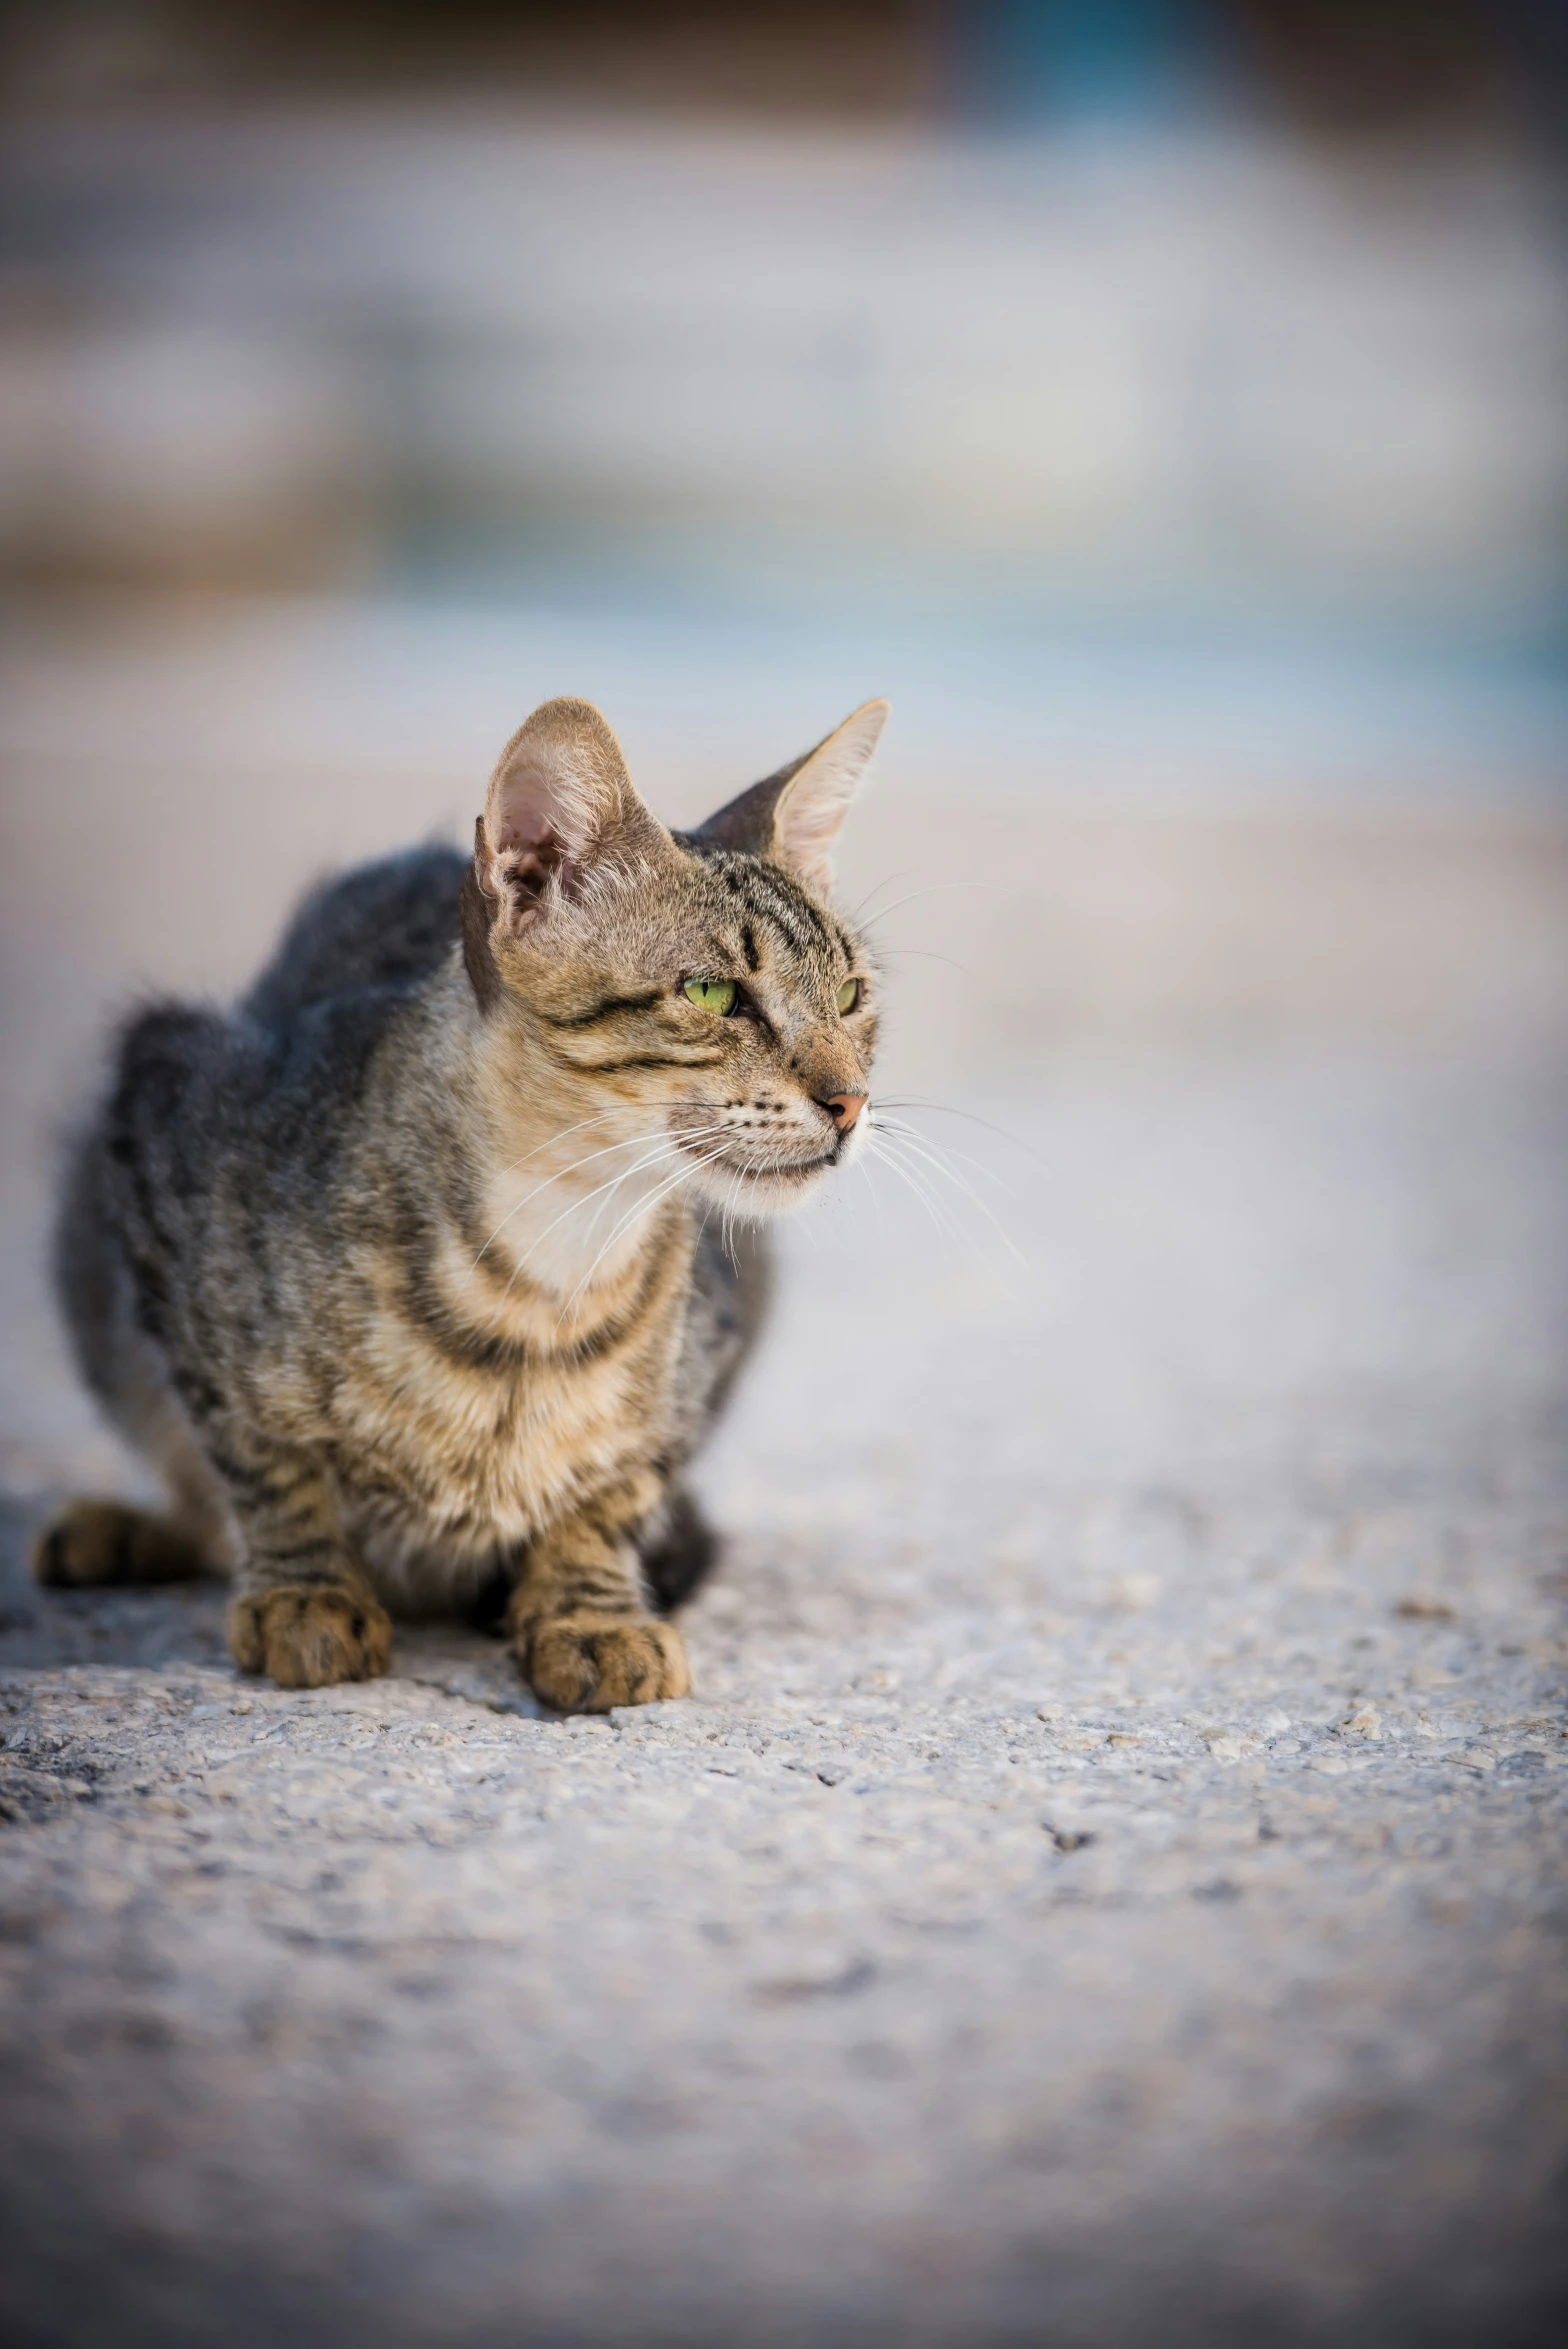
462,700 -> 887,1214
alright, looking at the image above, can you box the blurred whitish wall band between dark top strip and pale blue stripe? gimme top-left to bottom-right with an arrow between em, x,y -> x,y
0,115 -> 1568,618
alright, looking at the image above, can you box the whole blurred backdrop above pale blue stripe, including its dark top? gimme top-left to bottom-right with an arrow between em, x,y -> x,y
0,0 -> 1568,630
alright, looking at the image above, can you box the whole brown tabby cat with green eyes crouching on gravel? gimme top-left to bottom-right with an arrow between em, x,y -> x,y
33,700 -> 887,1712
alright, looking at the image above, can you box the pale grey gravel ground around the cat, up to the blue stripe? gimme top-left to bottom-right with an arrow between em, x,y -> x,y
0,613 -> 1568,2349
